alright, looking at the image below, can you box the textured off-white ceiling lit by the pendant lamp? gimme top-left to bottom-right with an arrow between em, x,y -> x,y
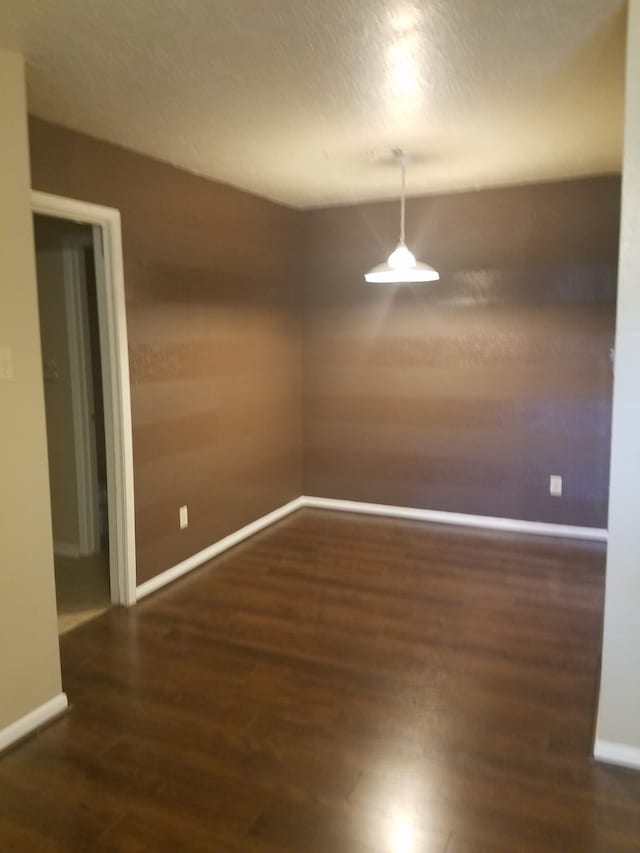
0,0 -> 625,207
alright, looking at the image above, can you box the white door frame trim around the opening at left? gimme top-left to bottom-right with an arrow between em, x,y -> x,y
31,190 -> 136,606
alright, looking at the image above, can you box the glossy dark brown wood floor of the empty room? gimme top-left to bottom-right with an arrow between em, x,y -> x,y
0,511 -> 640,853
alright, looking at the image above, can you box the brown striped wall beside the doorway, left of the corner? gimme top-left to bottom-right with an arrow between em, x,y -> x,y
30,119 -> 302,583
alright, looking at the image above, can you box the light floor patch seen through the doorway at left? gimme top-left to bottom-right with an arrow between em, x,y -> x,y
54,551 -> 111,634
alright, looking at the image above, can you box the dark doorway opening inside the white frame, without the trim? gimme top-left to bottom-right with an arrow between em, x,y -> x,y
34,214 -> 111,634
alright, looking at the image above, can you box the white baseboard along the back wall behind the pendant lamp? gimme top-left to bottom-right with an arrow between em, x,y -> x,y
301,495 -> 607,542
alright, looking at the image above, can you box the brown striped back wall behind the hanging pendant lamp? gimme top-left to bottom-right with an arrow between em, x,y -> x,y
303,177 -> 620,527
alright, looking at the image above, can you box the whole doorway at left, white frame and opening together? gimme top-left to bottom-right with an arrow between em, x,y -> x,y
32,192 -> 136,620
